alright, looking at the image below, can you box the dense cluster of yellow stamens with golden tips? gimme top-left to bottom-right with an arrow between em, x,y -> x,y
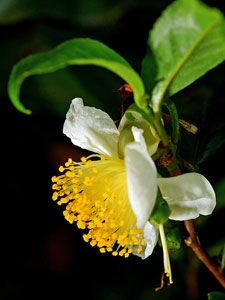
52,155 -> 145,257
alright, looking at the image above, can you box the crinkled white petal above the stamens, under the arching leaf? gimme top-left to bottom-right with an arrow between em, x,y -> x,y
63,98 -> 119,156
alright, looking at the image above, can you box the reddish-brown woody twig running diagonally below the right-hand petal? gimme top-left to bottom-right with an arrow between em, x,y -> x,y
184,220 -> 225,288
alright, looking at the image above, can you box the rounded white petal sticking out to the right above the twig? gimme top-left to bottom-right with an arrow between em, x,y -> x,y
158,173 -> 216,221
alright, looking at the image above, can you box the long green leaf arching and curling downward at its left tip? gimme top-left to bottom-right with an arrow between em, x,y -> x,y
8,38 -> 146,114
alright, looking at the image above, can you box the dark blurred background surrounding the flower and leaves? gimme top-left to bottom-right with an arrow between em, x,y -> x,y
0,0 -> 225,300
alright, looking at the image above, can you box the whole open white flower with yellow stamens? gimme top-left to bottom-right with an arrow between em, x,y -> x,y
53,98 -> 215,258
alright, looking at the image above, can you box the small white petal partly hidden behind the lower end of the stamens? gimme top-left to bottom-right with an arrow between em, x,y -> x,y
132,222 -> 158,259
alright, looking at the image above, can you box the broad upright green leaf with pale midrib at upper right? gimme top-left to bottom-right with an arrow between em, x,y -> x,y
142,0 -> 225,112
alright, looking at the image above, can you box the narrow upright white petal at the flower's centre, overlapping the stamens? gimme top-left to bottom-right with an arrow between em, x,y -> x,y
125,127 -> 157,228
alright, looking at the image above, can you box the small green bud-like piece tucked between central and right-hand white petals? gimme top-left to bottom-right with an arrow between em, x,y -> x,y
149,191 -> 171,226
